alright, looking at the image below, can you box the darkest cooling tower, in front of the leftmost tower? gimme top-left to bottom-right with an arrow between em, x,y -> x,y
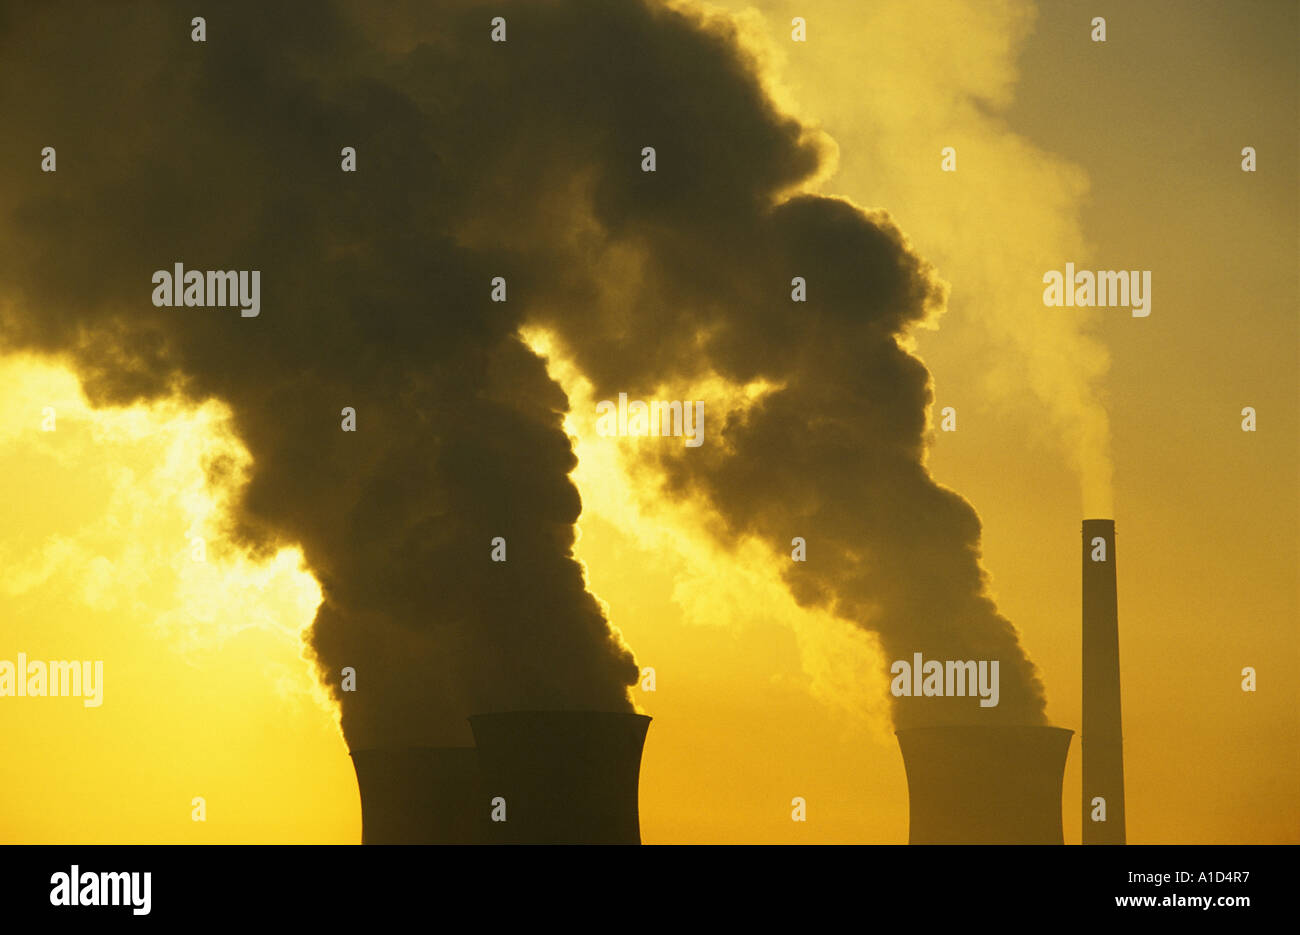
469,711 -> 650,844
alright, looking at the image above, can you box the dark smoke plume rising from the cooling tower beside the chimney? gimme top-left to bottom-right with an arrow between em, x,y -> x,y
377,4 -> 1044,724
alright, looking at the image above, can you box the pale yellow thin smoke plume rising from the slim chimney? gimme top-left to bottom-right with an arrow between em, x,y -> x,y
722,0 -> 1114,516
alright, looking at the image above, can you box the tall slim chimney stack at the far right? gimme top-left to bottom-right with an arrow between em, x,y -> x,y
1082,519 -> 1125,844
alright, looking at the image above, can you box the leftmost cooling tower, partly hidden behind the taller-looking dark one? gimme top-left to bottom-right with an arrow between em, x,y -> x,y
352,746 -> 488,844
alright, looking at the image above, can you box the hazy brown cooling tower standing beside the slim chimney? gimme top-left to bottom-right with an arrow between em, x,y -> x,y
897,726 -> 1073,844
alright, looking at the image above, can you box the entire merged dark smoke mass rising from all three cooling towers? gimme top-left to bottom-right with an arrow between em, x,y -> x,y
0,0 -> 1043,733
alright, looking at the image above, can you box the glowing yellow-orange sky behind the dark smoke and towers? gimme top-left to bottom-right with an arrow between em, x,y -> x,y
0,0 -> 1300,843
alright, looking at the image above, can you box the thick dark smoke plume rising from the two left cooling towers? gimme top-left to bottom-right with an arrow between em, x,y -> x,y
0,4 -> 637,748
